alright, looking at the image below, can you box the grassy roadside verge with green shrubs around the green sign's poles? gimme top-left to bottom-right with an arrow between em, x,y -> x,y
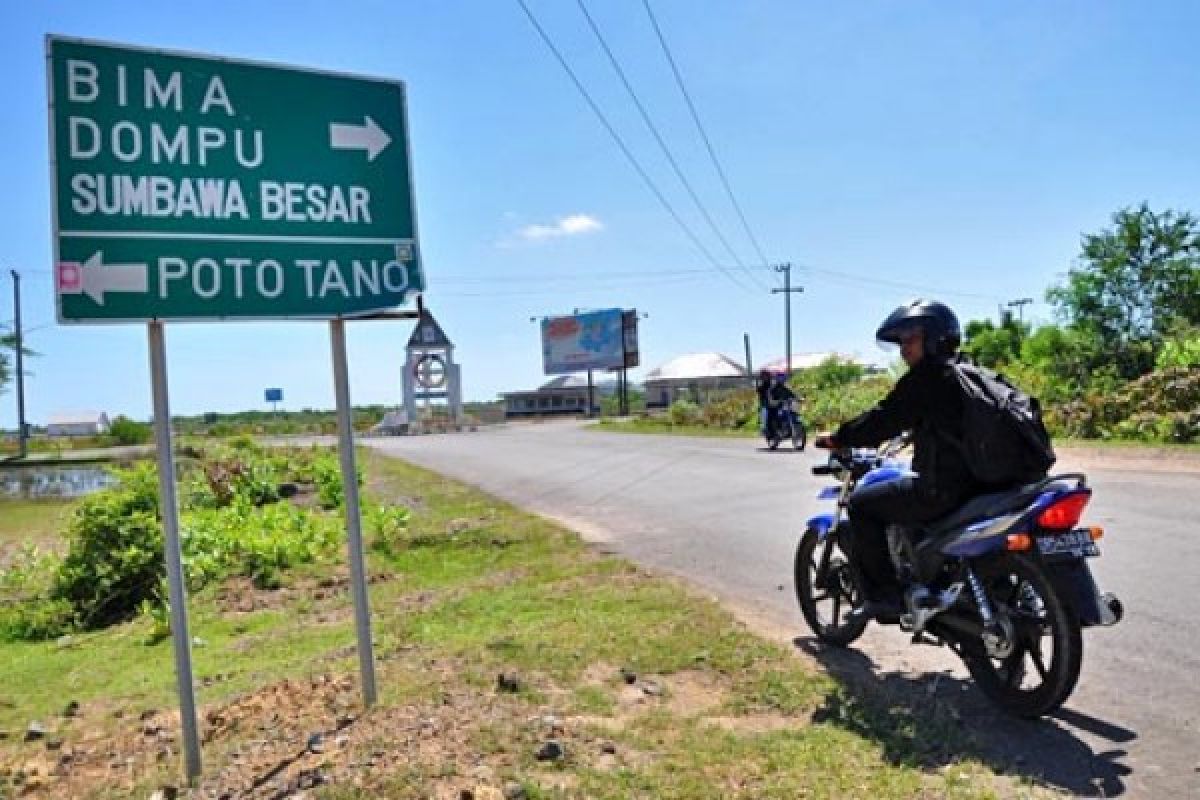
0,440 -> 1050,800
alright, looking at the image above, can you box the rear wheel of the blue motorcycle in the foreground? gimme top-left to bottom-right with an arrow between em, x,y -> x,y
962,554 -> 1084,718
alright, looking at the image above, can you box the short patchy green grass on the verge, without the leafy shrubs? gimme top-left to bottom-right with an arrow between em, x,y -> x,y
0,453 -> 1056,800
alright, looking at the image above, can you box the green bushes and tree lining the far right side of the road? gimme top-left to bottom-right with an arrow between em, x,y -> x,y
601,205 -> 1200,444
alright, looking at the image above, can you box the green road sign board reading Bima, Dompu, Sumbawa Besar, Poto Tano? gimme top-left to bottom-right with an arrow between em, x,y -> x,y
47,36 -> 425,323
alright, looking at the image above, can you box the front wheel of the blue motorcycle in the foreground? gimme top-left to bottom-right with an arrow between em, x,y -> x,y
793,528 -> 866,648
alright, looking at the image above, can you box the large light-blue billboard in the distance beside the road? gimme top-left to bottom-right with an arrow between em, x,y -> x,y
541,308 -> 625,375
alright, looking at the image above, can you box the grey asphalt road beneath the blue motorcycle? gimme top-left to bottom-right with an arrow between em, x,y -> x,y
364,422 -> 1200,798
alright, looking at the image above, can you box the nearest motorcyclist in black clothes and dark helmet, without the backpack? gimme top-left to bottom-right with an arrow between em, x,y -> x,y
814,300 -> 983,619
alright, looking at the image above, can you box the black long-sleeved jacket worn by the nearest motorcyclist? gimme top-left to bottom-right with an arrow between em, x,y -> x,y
834,360 -> 983,501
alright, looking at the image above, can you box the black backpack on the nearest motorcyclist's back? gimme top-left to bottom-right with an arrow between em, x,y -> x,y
952,361 -> 1056,486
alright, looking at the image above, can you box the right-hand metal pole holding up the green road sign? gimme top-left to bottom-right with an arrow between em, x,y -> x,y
329,319 -> 376,706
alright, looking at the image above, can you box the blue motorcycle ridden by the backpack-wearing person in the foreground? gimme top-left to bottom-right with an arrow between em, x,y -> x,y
794,439 -> 1123,717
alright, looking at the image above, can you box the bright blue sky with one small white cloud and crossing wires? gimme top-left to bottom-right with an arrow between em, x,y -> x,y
0,0 -> 1200,427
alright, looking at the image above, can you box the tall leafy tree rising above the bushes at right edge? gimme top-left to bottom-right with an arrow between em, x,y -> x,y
1046,204 -> 1200,378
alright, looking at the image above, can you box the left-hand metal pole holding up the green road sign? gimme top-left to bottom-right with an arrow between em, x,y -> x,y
148,320 -> 200,782
